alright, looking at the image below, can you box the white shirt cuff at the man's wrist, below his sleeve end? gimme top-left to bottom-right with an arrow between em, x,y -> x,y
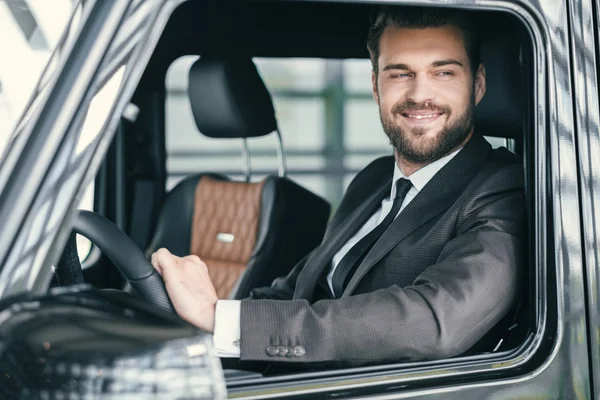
213,300 -> 241,357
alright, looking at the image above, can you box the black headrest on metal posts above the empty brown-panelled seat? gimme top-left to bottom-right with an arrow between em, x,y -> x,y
188,57 -> 277,138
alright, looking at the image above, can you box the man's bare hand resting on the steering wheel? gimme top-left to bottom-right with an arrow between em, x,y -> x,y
152,249 -> 218,333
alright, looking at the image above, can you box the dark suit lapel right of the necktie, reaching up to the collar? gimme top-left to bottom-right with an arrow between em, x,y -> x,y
342,134 -> 491,297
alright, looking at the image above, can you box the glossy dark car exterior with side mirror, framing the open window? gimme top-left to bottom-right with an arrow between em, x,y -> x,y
0,0 -> 600,399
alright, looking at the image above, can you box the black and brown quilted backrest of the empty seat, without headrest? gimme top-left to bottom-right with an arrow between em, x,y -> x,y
146,174 -> 331,299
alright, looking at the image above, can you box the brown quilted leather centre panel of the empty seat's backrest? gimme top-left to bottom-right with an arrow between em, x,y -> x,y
190,176 -> 264,298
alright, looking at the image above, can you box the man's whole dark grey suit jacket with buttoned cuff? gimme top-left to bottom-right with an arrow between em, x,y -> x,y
240,135 -> 525,365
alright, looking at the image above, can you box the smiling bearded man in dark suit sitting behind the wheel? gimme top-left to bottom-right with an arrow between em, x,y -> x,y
152,8 -> 524,365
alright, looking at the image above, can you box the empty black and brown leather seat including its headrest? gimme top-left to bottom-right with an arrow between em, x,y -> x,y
148,58 -> 330,299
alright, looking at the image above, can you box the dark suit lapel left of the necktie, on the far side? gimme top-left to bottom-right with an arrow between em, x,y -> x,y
294,177 -> 392,299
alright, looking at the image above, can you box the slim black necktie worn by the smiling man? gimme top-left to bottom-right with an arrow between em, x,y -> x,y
331,178 -> 412,297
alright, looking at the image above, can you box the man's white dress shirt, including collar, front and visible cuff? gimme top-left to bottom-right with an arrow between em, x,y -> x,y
213,149 -> 461,357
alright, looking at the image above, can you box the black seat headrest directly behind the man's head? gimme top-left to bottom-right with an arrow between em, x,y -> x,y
475,32 -> 528,139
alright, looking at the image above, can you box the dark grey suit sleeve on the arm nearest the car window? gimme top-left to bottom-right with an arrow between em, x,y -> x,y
240,168 -> 524,365
